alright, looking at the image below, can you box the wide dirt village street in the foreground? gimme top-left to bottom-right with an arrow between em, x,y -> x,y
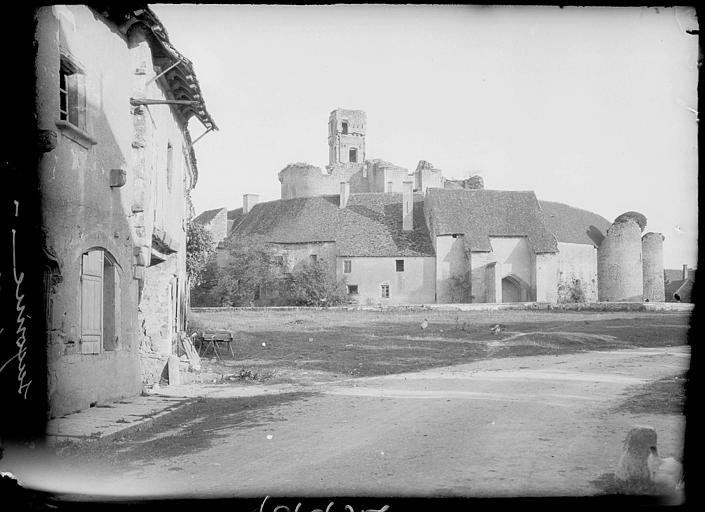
6,346 -> 689,496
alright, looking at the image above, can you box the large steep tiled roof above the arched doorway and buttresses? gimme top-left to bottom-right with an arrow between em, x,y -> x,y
426,189 -> 558,253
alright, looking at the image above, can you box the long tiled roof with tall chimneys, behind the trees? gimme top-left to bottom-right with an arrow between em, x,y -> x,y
231,193 -> 434,257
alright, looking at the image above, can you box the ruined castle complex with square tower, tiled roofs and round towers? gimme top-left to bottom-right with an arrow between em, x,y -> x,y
210,109 -> 664,304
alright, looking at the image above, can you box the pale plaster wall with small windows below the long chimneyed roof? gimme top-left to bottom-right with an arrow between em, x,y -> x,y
337,257 -> 436,305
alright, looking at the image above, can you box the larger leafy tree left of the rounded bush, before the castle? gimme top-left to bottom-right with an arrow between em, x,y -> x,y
211,235 -> 284,306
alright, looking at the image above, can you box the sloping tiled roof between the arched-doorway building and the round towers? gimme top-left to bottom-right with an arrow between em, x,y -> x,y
539,201 -> 611,247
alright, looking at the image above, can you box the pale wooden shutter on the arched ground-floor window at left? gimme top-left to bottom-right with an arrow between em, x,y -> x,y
81,251 -> 103,354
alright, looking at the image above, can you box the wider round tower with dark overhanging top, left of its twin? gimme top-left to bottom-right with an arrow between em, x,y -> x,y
597,216 -> 644,302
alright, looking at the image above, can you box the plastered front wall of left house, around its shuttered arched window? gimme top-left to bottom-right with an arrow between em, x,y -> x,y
36,6 -> 140,416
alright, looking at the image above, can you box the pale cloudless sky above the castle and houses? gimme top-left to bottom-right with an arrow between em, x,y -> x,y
152,4 -> 698,268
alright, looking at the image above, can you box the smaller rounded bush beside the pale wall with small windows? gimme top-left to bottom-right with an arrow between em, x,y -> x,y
287,260 -> 349,306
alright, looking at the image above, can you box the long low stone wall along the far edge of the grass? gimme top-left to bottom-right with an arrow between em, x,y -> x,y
191,302 -> 695,313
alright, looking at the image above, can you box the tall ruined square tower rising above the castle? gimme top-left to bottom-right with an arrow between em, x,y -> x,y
328,108 -> 367,165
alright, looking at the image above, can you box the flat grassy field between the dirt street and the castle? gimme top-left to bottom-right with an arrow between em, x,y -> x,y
190,310 -> 690,380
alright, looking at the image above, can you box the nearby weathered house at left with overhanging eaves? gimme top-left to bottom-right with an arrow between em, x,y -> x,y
36,5 -> 217,416
